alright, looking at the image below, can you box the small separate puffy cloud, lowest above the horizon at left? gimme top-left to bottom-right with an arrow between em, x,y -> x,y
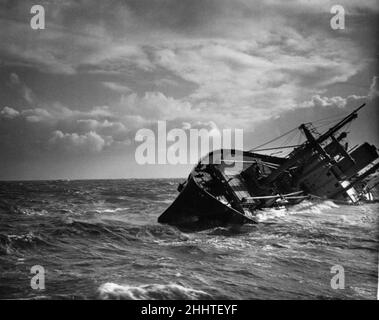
49,130 -> 110,152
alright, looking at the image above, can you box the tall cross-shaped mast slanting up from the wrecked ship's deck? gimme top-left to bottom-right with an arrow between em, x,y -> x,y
265,103 -> 366,184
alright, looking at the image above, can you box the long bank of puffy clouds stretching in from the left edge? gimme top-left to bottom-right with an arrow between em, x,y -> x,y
0,104 -> 137,152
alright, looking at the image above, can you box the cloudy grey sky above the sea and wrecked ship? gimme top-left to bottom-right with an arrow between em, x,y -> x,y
0,0 -> 379,180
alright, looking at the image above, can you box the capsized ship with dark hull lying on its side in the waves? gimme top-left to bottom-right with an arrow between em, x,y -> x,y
158,104 -> 379,229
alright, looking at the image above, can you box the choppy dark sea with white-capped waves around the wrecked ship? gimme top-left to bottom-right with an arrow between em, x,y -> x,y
0,179 -> 379,300
